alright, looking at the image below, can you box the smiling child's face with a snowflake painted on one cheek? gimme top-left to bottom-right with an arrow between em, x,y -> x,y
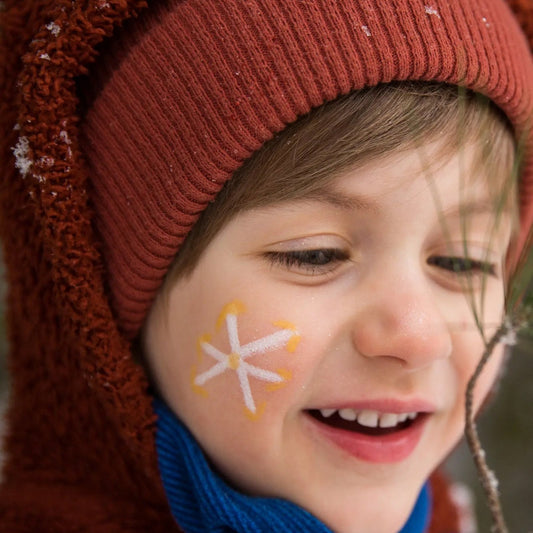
146,141 -> 510,533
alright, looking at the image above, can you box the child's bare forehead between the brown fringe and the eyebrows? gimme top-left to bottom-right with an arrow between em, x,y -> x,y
309,141 -> 514,214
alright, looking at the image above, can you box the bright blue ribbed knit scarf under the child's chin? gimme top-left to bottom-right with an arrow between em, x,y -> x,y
155,400 -> 431,533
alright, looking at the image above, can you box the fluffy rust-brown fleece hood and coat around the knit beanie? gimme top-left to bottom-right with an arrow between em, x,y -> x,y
0,0 -> 531,533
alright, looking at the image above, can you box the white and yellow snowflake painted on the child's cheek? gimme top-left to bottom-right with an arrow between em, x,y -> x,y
192,301 -> 300,419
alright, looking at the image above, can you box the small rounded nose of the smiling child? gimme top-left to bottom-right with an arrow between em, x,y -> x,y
353,274 -> 452,369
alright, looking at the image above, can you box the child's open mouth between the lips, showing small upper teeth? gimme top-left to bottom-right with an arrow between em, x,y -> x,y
307,408 -> 426,437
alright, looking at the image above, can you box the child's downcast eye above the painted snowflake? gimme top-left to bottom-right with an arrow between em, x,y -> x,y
265,248 -> 350,275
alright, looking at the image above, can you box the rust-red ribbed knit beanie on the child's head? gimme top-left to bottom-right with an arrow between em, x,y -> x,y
83,0 -> 533,336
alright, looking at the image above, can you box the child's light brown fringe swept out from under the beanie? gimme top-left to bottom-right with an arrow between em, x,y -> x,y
164,82 -> 516,287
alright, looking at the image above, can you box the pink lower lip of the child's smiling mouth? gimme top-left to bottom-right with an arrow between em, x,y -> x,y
307,415 -> 428,463
